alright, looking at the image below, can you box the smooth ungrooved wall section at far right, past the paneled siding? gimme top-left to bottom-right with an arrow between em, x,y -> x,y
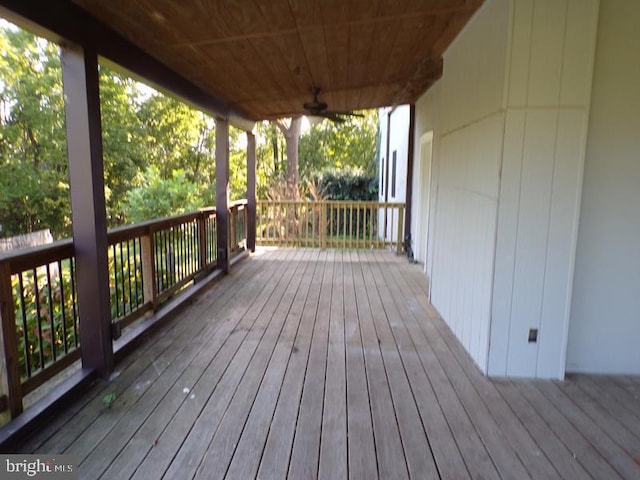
567,0 -> 640,375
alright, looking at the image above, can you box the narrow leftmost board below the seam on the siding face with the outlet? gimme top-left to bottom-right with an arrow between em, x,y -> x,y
488,111 -> 526,376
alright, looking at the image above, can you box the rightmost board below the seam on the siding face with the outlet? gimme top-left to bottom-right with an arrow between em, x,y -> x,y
537,110 -> 586,378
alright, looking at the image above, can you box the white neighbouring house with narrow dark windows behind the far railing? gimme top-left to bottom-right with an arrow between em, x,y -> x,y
378,105 -> 411,246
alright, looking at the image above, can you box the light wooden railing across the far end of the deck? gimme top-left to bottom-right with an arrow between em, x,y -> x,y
256,200 -> 404,253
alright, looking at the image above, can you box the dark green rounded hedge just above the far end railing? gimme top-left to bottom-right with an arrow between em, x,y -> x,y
312,168 -> 378,201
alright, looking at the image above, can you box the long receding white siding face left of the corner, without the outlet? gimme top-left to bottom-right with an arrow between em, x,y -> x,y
416,0 -> 509,371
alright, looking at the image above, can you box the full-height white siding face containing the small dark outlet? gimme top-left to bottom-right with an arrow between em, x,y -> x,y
489,0 -> 598,378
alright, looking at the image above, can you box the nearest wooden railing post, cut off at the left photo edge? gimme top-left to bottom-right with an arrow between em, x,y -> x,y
0,262 -> 22,423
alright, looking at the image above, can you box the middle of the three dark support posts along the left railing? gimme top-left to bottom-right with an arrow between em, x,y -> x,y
216,119 -> 231,272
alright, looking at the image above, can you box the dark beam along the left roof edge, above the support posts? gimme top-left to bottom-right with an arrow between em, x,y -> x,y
0,0 -> 253,128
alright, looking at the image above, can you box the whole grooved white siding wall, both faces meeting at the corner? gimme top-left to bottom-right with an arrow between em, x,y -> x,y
414,0 -> 598,377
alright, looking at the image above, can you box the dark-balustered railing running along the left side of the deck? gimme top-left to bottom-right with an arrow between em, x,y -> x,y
0,201 -> 247,416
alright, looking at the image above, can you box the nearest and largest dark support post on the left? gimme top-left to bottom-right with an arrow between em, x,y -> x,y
62,46 -> 113,377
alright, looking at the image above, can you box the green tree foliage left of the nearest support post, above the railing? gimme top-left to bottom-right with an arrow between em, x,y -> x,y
0,28 -> 71,236
